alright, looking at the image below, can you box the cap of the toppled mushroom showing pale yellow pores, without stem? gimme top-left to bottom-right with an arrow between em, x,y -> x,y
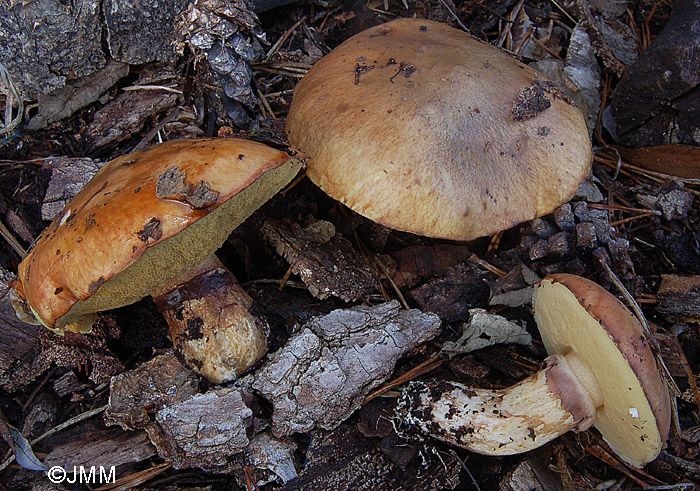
533,274 -> 671,467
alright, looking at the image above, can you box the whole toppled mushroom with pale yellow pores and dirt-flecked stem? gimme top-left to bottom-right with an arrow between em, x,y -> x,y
395,274 -> 671,467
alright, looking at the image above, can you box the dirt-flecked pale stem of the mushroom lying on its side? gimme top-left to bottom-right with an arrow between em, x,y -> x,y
395,355 -> 600,455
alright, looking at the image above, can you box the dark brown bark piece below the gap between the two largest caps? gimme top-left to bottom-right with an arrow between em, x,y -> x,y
262,218 -> 377,302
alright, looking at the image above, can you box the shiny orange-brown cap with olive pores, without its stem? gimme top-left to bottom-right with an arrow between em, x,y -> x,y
15,138 -> 300,332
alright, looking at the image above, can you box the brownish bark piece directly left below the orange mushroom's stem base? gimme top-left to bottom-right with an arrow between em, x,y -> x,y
104,351 -> 199,430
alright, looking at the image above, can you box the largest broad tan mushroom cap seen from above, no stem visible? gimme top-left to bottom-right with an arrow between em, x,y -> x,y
287,19 -> 592,240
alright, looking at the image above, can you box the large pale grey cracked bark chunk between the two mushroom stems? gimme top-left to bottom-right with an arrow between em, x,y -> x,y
253,301 -> 440,436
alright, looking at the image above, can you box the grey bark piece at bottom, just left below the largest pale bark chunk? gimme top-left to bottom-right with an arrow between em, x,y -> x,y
146,388 -> 253,470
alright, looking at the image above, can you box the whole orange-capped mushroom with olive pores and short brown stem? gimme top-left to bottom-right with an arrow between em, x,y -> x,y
13,138 -> 301,382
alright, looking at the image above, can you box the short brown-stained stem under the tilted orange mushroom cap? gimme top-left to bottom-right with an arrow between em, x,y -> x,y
153,254 -> 268,383
